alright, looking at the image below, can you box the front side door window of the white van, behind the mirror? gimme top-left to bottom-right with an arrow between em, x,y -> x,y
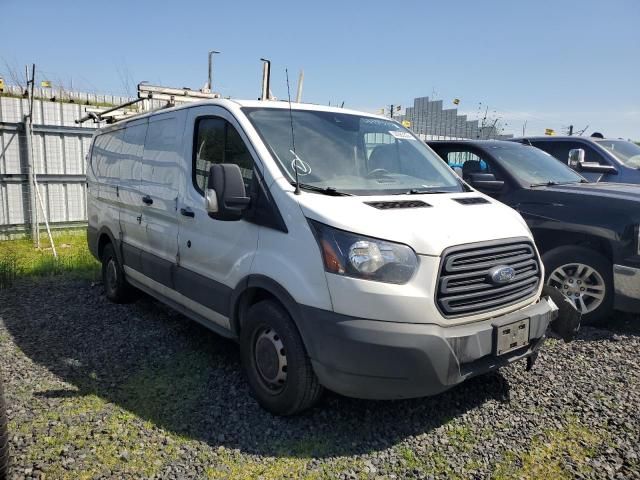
193,117 -> 253,193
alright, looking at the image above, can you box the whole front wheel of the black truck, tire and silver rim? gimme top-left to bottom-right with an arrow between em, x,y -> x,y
542,246 -> 614,325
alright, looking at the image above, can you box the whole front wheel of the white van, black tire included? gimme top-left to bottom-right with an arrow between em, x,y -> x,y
240,300 -> 323,415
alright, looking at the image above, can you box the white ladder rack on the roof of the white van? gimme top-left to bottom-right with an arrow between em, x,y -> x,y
75,82 -> 220,123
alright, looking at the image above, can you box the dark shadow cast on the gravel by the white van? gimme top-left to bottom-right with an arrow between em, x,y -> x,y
0,280 -> 524,457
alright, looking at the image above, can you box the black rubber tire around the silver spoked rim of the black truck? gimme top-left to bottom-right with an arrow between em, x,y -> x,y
542,245 -> 614,325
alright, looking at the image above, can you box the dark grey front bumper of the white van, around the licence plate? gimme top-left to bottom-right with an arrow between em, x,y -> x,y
301,297 -> 558,400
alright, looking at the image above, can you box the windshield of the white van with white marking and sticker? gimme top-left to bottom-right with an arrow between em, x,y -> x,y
243,107 -> 463,195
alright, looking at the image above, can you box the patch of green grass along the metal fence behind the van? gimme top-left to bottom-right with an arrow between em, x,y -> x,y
0,229 -> 100,289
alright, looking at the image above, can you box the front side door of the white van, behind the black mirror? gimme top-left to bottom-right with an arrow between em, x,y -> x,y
176,105 -> 259,328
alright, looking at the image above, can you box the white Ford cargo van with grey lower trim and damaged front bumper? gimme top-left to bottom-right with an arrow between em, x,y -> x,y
87,99 -> 558,415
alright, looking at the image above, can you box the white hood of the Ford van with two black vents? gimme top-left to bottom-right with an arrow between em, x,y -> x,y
295,192 -> 531,256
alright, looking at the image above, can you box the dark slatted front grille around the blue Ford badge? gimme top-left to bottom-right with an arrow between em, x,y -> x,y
436,240 -> 540,317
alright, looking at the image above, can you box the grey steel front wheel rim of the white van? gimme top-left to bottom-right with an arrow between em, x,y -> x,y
253,327 -> 287,393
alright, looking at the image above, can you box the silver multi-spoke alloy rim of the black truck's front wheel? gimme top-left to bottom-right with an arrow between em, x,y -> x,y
547,263 -> 606,315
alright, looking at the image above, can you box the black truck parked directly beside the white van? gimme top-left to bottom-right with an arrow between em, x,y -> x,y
428,140 -> 640,324
